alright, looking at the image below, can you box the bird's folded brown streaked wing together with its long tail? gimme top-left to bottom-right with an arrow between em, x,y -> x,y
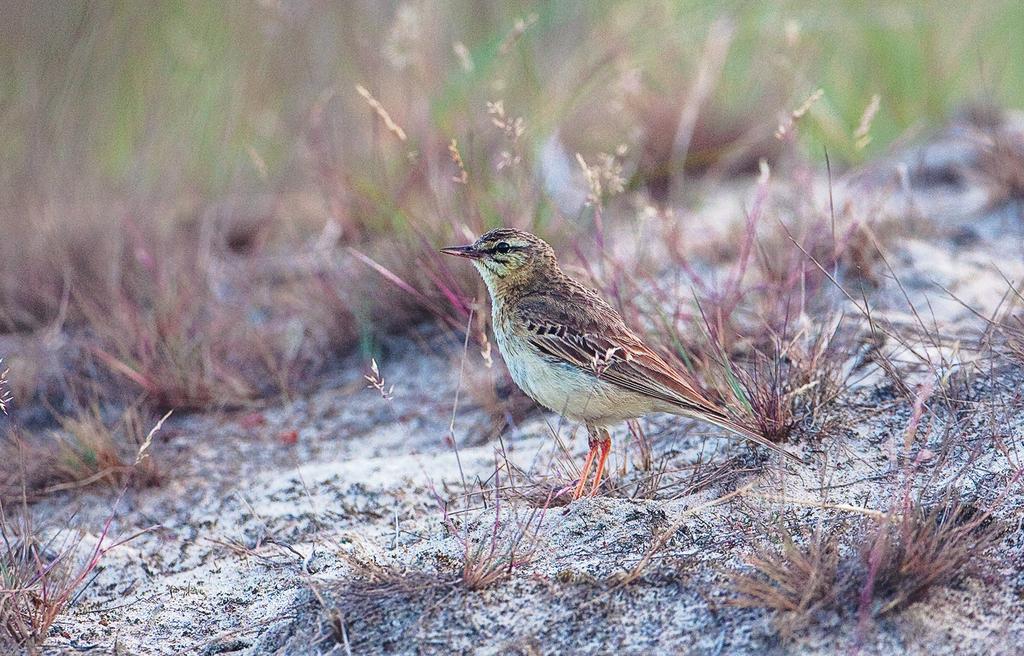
516,299 -> 803,463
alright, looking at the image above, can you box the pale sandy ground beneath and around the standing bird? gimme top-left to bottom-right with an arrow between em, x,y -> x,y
28,121 -> 1024,656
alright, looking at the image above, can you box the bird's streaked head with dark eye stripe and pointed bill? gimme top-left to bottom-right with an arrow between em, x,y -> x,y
441,228 -> 558,296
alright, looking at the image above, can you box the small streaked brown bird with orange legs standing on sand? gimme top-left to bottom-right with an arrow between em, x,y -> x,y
440,227 -> 802,499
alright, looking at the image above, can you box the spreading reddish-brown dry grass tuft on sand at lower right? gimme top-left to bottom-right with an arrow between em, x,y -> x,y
732,493 -> 1000,640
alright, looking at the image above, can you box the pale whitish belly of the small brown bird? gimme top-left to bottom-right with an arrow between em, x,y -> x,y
495,330 -> 654,426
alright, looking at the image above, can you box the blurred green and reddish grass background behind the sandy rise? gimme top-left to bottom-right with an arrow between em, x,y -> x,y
0,0 -> 1024,426
